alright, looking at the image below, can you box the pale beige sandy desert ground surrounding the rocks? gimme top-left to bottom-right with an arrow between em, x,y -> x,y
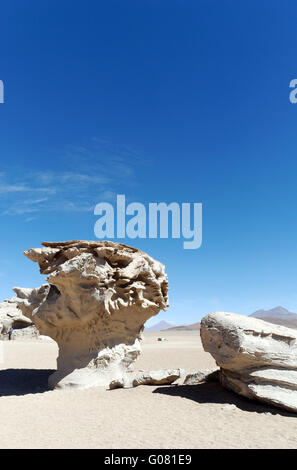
0,332 -> 297,449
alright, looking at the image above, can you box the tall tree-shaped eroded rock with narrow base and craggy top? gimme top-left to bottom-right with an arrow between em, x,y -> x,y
14,241 -> 169,388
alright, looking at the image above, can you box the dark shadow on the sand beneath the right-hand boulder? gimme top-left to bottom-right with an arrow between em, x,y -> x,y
153,382 -> 297,418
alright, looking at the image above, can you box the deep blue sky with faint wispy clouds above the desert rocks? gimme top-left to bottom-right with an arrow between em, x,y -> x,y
0,0 -> 297,324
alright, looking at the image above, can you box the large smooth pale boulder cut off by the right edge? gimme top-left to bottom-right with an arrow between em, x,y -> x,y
200,312 -> 297,412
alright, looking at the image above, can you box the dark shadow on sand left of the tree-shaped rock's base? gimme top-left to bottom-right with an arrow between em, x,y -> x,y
0,369 -> 55,397
